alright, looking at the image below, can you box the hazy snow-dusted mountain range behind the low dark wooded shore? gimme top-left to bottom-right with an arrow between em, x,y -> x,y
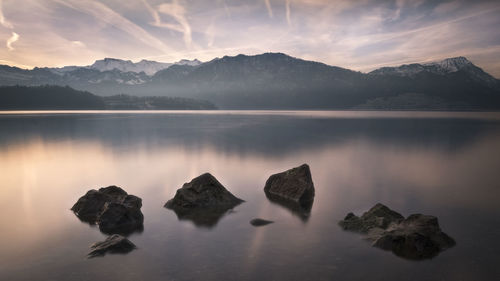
0,53 -> 500,110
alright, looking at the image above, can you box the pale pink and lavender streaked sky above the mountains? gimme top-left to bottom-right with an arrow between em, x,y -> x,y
0,0 -> 500,78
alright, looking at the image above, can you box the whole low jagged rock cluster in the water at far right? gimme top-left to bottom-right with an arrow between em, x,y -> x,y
339,204 -> 455,260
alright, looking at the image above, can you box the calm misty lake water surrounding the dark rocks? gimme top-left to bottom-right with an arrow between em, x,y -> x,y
0,111 -> 500,280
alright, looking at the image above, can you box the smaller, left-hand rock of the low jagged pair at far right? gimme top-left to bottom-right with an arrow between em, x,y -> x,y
339,203 -> 404,233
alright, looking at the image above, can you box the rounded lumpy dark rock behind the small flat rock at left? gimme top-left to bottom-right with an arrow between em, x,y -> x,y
71,186 -> 144,234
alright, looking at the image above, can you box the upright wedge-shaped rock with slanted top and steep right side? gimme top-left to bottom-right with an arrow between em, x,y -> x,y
264,164 -> 314,203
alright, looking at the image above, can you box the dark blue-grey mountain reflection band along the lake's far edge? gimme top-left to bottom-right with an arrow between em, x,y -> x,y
0,114 -> 498,157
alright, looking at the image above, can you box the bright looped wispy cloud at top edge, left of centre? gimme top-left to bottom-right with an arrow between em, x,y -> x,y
142,0 -> 193,46
